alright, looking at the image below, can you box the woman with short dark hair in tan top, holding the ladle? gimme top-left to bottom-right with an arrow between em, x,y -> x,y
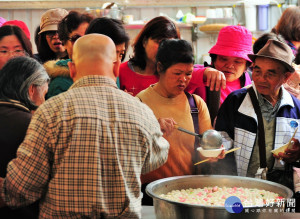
137,39 -> 212,205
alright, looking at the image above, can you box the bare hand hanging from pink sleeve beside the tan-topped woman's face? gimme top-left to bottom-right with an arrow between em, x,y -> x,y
203,68 -> 226,91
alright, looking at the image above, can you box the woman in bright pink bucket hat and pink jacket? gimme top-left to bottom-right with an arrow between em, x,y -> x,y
186,25 -> 253,122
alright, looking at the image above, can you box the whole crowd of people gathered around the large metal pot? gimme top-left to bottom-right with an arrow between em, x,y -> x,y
0,4 -> 300,218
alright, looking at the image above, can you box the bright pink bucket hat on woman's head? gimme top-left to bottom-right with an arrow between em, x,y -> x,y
208,25 -> 253,62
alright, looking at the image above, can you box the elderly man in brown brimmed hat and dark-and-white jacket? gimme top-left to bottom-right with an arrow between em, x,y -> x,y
215,40 -> 300,188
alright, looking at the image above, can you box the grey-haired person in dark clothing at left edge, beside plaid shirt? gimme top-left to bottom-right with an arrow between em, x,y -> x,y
0,56 -> 50,218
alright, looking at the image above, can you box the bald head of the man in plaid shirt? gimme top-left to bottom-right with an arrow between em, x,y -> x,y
69,34 -> 117,81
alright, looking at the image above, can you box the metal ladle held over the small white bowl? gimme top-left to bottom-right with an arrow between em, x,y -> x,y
175,126 -> 222,150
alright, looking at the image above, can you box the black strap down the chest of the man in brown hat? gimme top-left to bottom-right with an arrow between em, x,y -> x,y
248,87 -> 267,168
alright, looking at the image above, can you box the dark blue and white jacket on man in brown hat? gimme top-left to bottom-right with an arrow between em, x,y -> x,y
215,85 -> 300,176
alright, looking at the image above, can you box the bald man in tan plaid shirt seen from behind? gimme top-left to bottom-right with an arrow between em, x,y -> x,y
0,34 -> 169,218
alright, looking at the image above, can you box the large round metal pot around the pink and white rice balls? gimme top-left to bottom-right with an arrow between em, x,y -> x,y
146,175 -> 293,219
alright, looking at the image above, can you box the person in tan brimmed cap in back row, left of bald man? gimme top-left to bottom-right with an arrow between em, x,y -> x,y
35,8 -> 68,63
